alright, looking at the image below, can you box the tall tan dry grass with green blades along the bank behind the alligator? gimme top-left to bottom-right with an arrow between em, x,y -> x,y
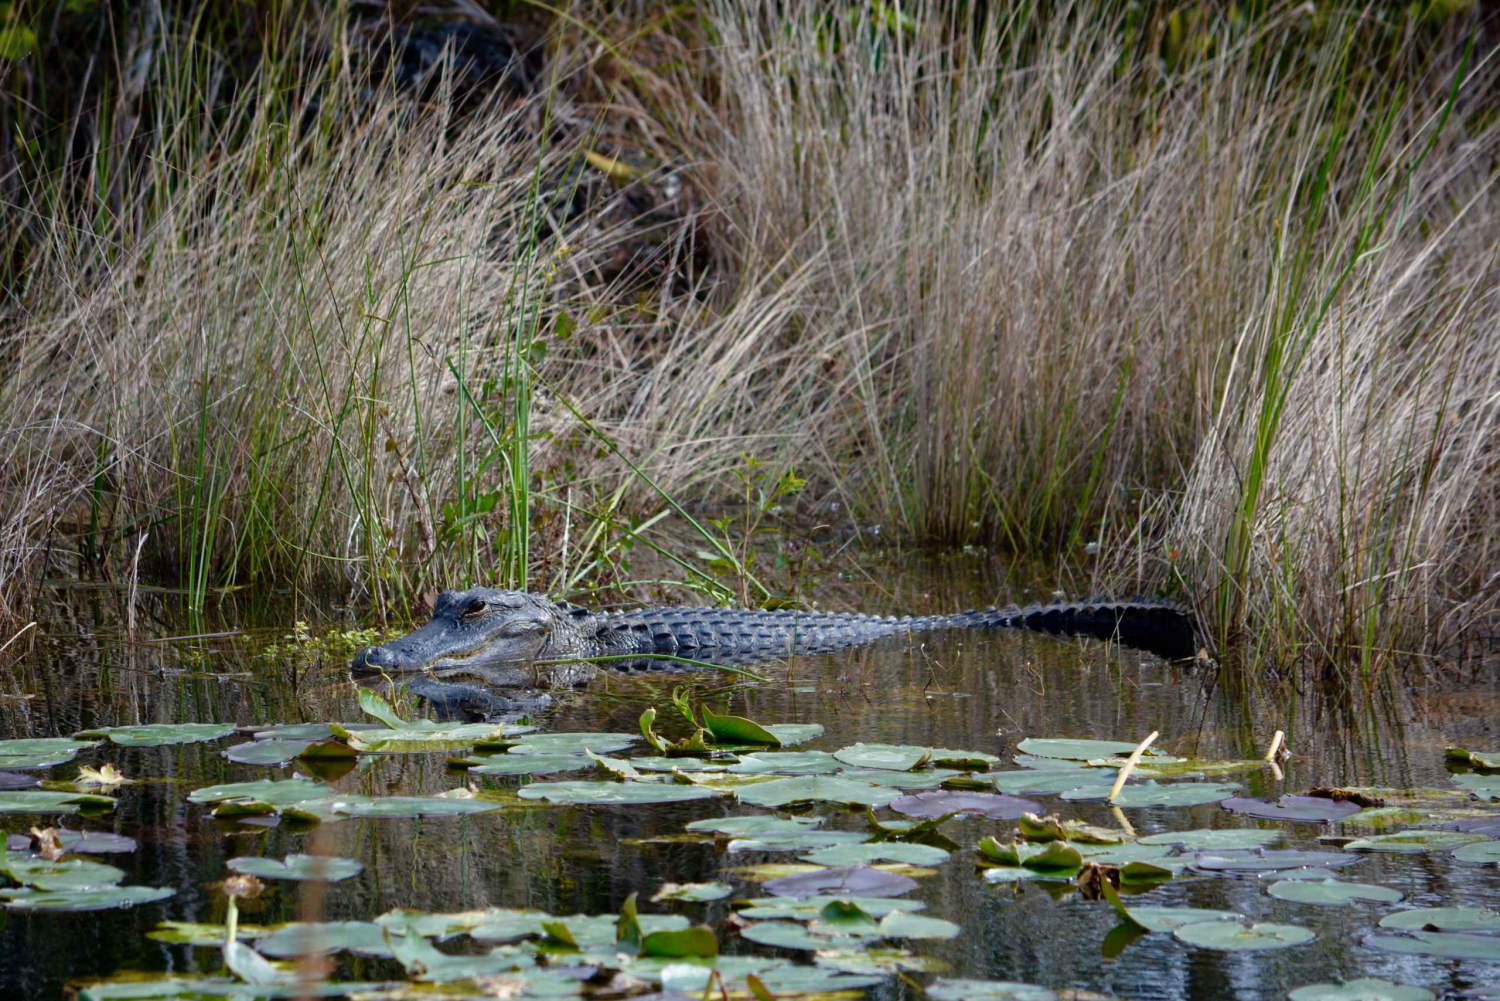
0,0 -> 1500,681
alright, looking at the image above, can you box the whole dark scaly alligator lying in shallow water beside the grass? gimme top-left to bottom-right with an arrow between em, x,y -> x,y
351,587 -> 1197,690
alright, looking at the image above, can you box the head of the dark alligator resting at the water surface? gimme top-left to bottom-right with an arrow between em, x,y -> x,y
351,587 -> 564,684
